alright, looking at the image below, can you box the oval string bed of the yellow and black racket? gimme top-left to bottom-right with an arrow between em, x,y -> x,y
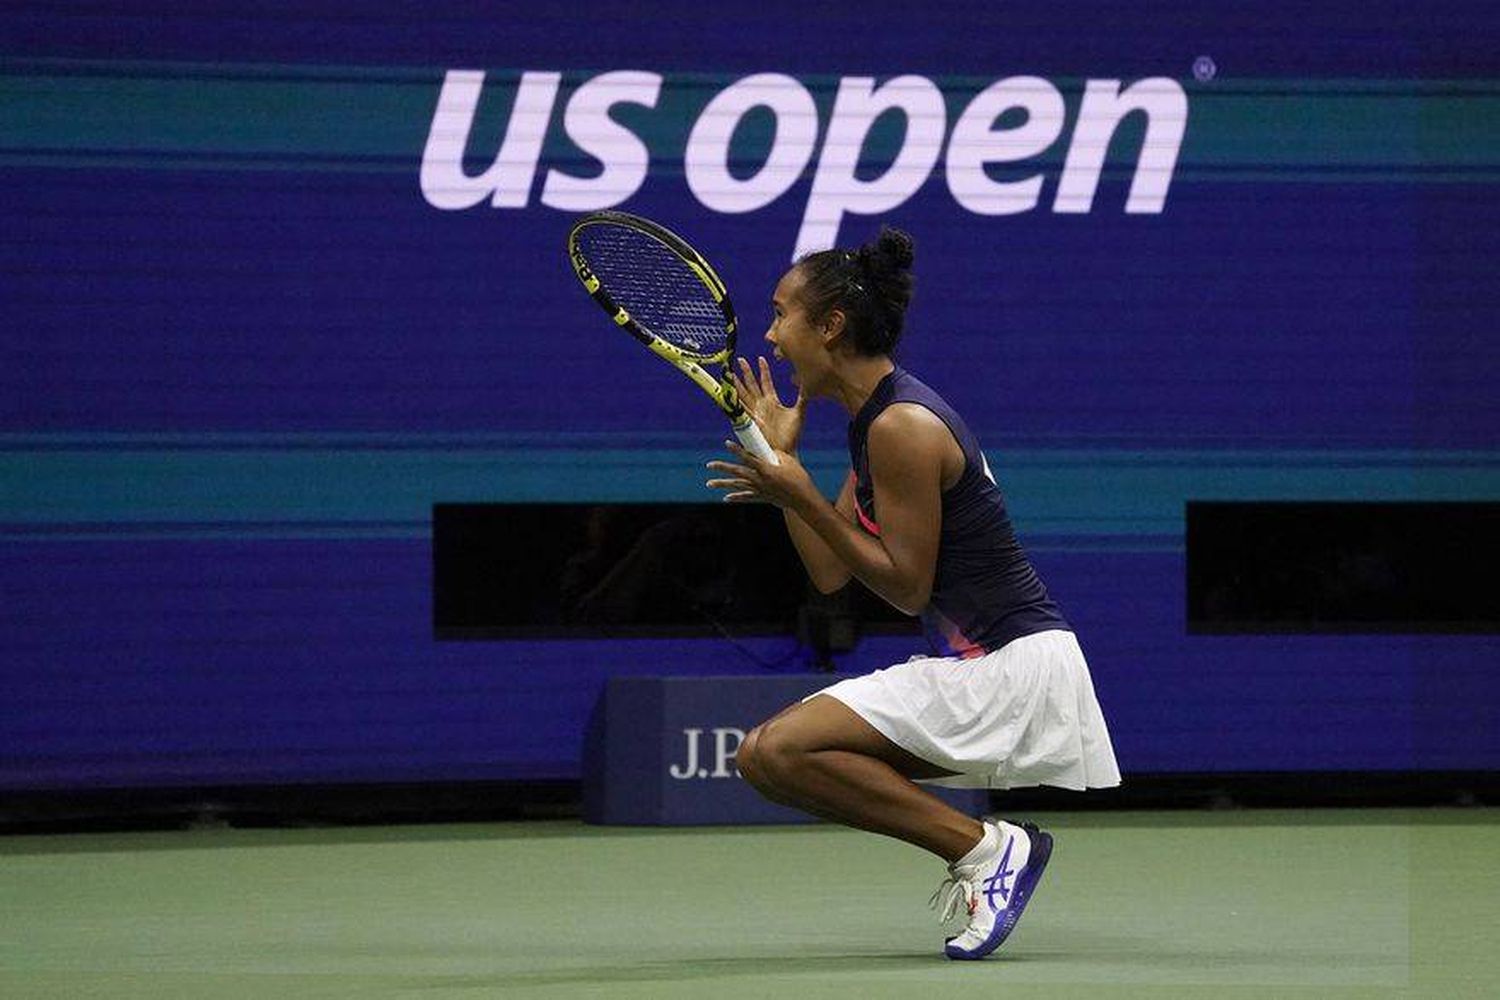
578,225 -> 731,357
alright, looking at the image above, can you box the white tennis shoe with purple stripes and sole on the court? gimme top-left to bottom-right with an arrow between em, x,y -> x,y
929,820 -> 1052,960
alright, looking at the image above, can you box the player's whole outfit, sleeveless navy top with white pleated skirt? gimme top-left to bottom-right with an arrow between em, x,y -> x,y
819,367 -> 1121,789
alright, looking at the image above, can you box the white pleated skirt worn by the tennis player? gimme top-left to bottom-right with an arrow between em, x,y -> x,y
812,630 -> 1121,790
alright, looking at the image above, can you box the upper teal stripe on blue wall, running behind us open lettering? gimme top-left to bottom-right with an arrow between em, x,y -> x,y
0,60 -> 1500,183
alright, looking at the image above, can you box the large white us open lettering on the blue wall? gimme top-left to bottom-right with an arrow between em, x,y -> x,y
420,69 -> 1188,259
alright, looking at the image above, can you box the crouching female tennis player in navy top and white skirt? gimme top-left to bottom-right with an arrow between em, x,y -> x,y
708,229 -> 1119,958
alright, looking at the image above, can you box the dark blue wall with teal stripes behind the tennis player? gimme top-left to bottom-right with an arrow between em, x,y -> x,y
0,0 -> 1500,789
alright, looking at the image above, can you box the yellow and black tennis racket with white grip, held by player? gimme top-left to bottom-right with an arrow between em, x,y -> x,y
567,211 -> 777,465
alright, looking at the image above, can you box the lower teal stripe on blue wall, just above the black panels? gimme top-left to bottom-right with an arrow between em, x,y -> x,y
0,436 -> 1500,550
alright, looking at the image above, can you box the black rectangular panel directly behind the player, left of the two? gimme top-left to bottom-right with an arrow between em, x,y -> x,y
432,502 -> 911,639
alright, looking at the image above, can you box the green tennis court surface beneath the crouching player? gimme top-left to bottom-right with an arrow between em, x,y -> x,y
0,810 -> 1500,1000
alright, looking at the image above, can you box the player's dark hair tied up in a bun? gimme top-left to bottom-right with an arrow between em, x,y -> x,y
797,226 -> 917,354
